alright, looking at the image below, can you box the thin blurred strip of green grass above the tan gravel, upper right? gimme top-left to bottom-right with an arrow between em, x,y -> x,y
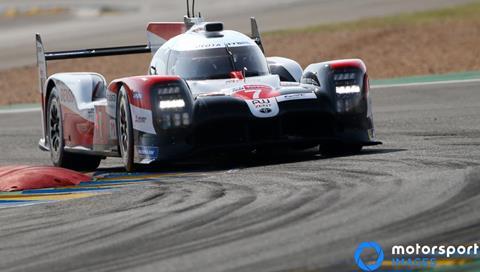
264,1 -> 480,36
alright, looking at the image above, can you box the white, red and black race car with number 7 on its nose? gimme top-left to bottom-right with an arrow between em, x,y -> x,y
36,5 -> 380,171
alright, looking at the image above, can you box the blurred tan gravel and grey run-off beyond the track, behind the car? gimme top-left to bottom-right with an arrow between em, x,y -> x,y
0,0 -> 480,105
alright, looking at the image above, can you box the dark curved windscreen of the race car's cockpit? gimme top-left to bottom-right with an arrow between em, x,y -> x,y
168,46 -> 269,80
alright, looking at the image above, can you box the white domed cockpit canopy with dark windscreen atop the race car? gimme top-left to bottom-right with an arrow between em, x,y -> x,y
150,23 -> 270,80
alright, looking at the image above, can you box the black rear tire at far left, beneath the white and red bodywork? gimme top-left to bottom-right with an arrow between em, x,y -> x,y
47,87 -> 102,171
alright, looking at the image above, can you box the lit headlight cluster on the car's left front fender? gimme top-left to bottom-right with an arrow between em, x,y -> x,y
157,85 -> 191,129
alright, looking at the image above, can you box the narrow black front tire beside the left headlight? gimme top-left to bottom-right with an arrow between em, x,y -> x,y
116,87 -> 135,172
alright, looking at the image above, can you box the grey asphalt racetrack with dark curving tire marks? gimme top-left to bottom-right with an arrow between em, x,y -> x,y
0,83 -> 480,271
